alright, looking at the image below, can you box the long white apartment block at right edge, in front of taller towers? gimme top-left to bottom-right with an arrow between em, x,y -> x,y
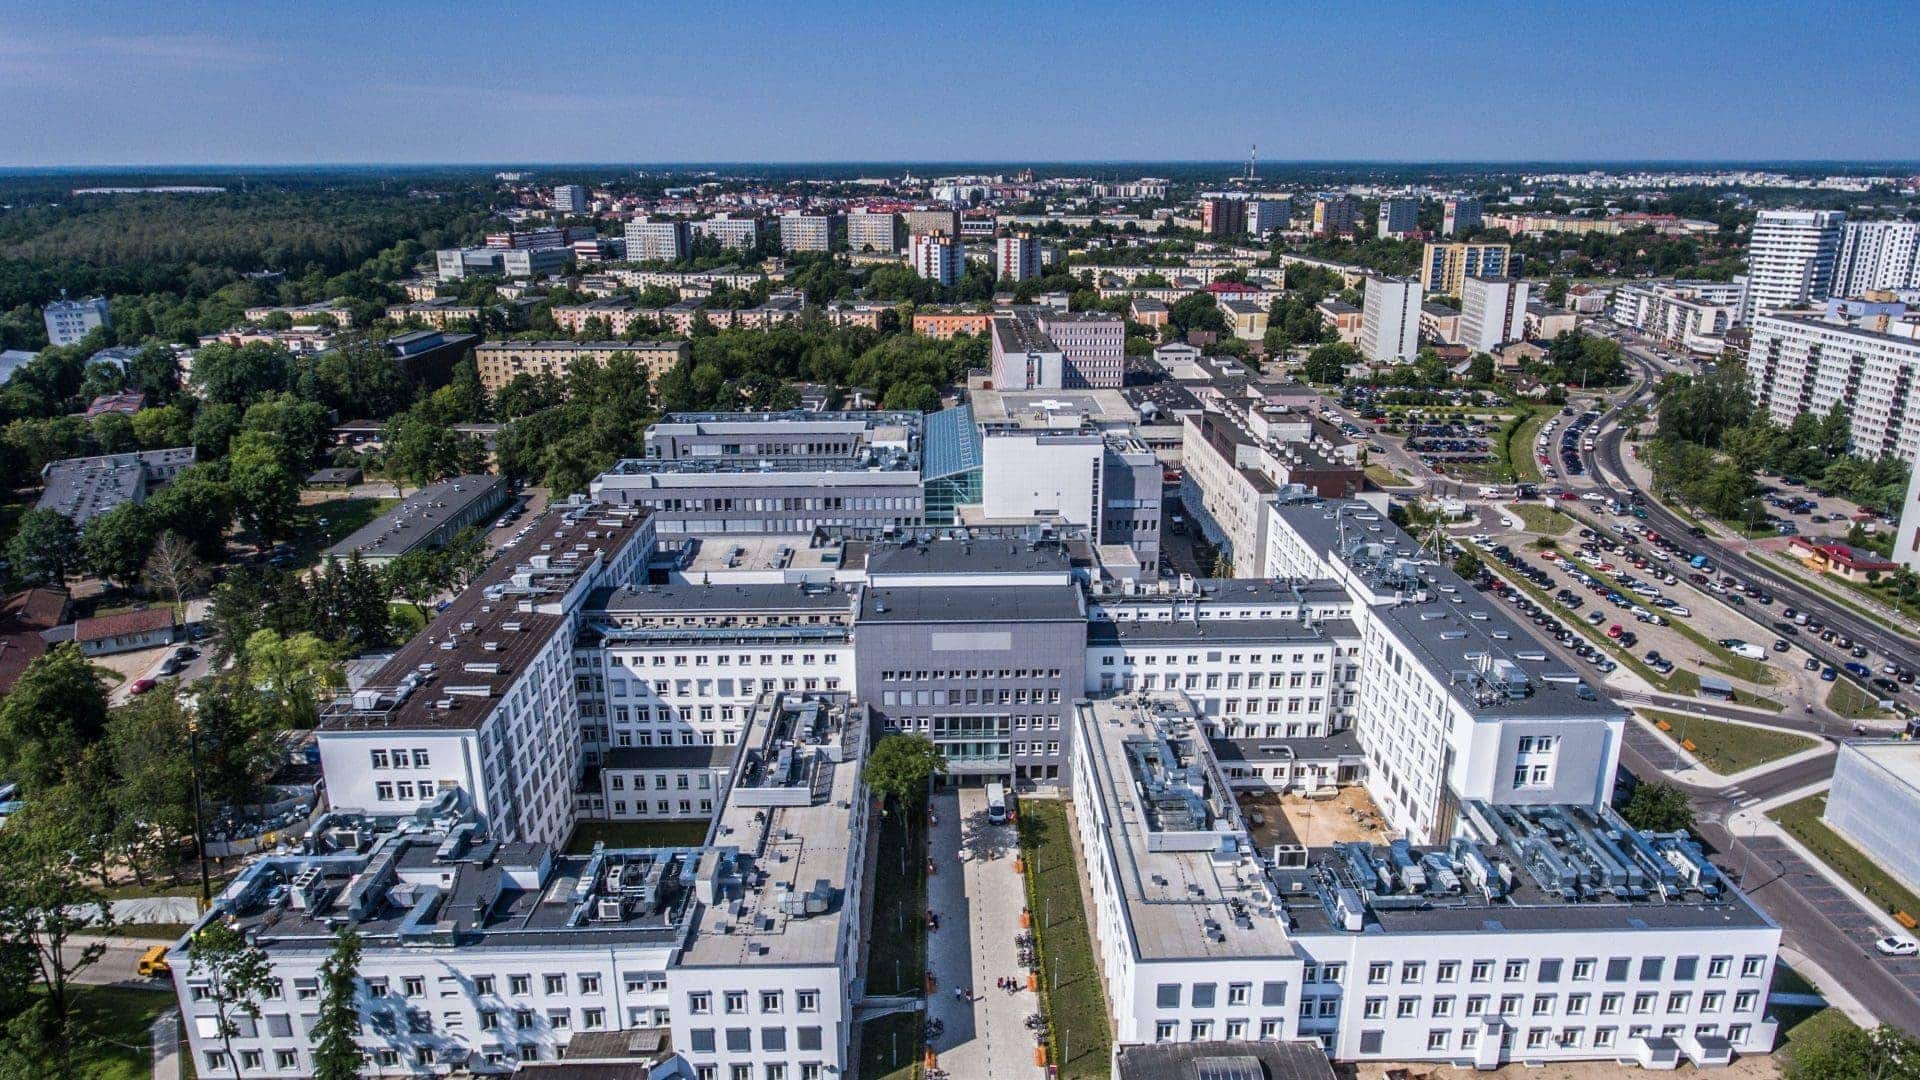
1747,311 -> 1920,461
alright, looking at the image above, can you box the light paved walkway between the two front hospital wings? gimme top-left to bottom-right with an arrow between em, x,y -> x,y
927,788 -> 1044,1080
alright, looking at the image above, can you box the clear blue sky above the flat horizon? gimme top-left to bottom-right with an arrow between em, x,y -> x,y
0,0 -> 1920,165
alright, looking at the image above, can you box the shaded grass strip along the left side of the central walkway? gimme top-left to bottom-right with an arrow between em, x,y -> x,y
860,809 -> 925,1080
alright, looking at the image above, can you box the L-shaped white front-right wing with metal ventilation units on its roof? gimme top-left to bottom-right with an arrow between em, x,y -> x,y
1073,696 -> 1780,1068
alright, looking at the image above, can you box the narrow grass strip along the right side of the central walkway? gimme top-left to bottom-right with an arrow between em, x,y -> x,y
1020,799 -> 1114,1076
